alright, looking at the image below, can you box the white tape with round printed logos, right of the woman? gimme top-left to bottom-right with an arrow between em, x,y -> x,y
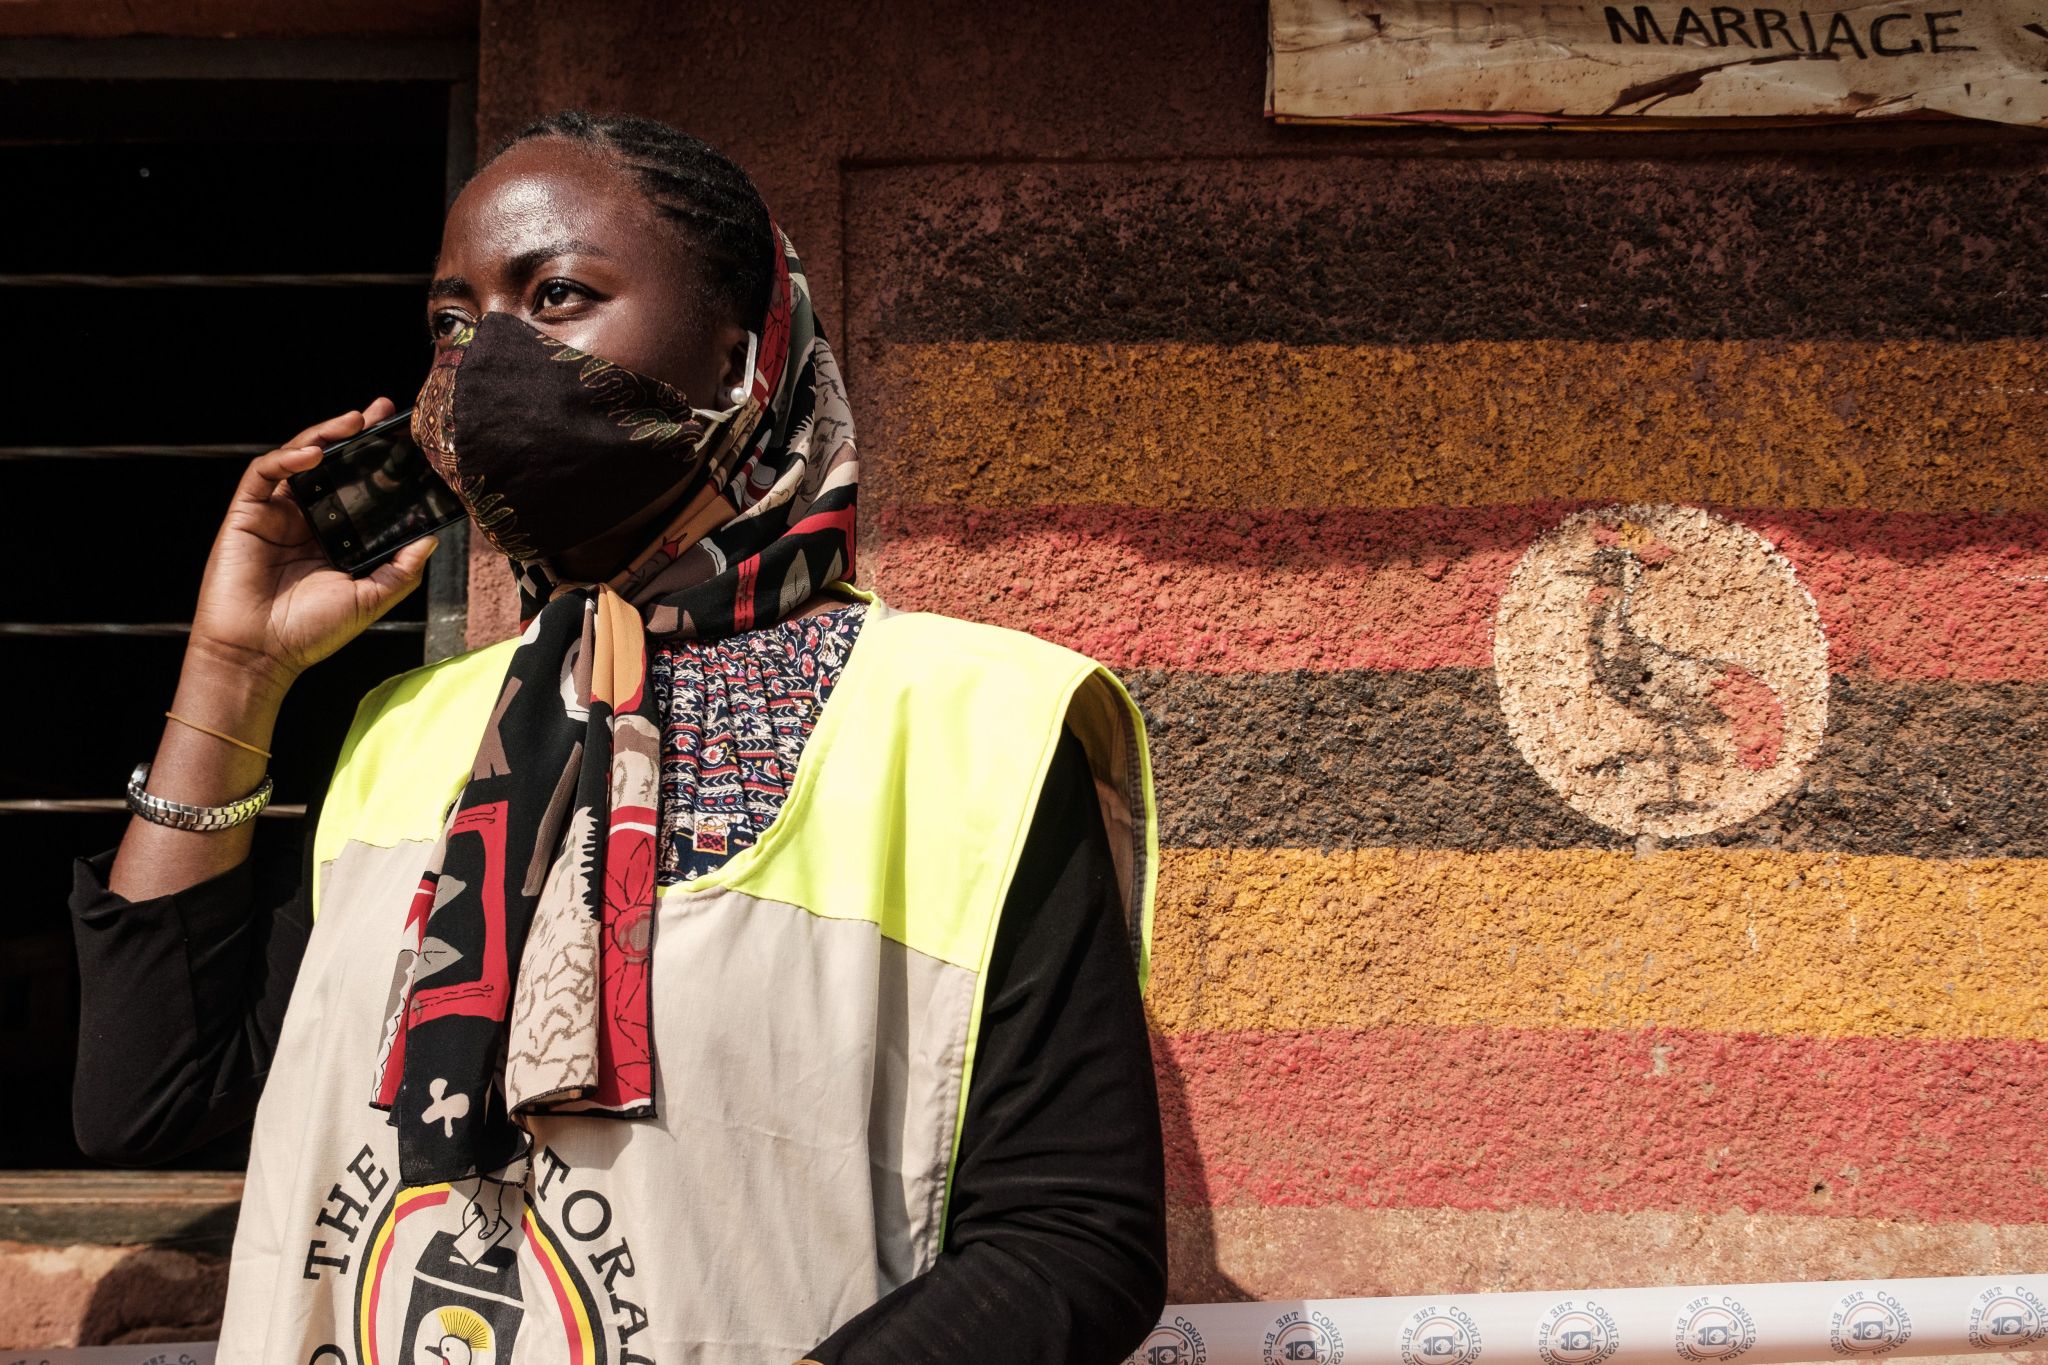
1130,1275 -> 2048,1365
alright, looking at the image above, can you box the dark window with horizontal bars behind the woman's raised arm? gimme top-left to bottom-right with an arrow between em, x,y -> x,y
0,39 -> 475,1171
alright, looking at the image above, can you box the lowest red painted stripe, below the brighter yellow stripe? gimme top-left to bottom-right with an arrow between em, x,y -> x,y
1153,1023 -> 2048,1224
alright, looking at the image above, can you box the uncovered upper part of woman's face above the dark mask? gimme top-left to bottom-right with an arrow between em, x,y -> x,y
426,137 -> 745,417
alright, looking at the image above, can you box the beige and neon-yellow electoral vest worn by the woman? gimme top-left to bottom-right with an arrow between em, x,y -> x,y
219,593 -> 1157,1365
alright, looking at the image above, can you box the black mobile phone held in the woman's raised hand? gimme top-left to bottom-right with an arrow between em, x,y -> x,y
285,407 -> 467,579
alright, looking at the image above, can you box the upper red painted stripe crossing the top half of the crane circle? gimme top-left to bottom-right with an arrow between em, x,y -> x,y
874,505 -> 2048,681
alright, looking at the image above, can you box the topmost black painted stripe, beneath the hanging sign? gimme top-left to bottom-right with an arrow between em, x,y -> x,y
850,143 -> 2048,344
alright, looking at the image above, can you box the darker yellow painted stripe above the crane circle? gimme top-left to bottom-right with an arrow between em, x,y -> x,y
858,340 -> 2048,510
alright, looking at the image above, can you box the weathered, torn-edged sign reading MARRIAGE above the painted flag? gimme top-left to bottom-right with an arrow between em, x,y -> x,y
1266,0 -> 2048,127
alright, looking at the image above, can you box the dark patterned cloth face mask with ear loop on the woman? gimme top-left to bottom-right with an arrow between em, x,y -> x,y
412,313 -> 760,561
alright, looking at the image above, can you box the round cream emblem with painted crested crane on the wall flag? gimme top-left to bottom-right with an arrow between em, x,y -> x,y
1493,505 -> 1827,837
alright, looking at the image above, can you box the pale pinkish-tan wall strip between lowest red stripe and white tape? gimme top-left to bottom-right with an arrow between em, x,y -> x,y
1167,1207 -> 2048,1301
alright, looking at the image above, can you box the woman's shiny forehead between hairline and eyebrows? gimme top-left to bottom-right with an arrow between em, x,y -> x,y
440,137 -> 684,270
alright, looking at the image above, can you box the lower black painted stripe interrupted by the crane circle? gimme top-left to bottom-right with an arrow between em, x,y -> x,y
1126,669 -> 2048,857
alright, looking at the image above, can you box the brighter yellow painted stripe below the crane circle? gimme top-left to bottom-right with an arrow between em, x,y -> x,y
1147,849 -> 2048,1040
